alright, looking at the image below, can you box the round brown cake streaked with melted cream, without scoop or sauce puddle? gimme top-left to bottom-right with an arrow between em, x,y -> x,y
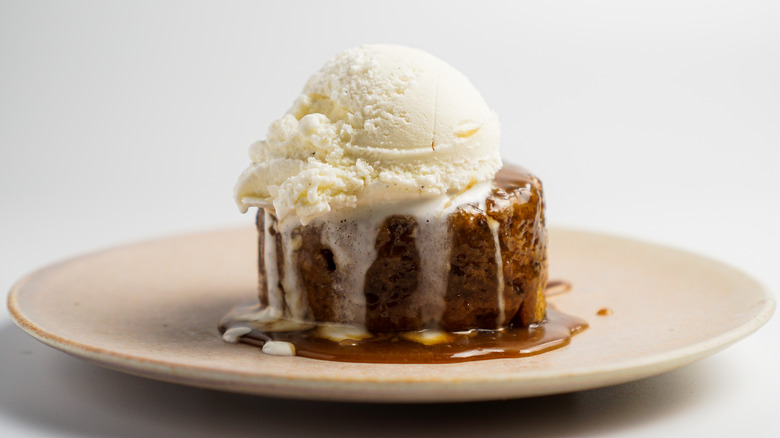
257,165 -> 547,332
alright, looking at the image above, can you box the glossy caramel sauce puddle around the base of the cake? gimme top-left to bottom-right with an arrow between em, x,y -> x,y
219,282 -> 588,364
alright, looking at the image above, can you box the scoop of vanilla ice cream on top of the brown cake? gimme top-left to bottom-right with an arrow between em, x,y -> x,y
235,45 -> 501,224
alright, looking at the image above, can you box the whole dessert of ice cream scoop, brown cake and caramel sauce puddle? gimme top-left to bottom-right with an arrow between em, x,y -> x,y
221,45 -> 581,362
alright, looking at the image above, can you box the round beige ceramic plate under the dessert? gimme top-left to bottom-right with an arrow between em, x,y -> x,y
8,229 -> 775,402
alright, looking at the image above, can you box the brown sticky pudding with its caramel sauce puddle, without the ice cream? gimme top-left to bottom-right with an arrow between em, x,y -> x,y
220,165 -> 587,363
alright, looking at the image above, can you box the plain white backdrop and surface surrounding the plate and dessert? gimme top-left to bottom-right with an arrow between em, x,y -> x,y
0,1 -> 780,437
